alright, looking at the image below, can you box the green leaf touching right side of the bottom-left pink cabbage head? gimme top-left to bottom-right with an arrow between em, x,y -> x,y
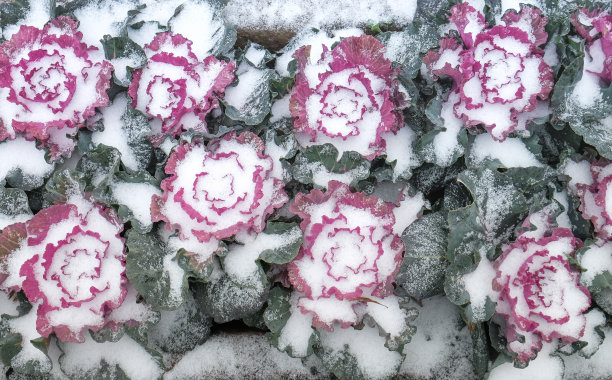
125,230 -> 189,310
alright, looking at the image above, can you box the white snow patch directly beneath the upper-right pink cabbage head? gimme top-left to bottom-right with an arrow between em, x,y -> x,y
469,133 -> 544,168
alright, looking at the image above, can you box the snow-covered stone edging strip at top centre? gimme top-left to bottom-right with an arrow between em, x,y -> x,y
224,0 -> 417,31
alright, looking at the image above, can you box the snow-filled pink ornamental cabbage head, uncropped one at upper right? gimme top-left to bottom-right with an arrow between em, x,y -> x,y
423,3 -> 553,141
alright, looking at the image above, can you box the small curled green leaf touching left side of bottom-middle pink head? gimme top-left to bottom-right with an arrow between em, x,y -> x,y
259,222 -> 304,264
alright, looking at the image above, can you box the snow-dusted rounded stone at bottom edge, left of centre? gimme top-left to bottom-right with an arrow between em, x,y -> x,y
164,333 -> 326,380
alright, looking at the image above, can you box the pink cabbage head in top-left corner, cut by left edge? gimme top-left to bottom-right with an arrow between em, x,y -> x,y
0,16 -> 113,158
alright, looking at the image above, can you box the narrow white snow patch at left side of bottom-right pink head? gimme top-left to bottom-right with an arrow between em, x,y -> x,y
461,256 -> 497,321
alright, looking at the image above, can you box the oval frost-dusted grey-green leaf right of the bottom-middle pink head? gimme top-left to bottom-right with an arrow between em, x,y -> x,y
395,212 -> 448,299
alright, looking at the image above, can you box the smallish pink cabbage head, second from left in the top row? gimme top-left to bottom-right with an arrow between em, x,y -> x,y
129,32 -> 235,145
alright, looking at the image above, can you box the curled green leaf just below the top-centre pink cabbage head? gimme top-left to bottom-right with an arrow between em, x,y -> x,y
291,144 -> 370,188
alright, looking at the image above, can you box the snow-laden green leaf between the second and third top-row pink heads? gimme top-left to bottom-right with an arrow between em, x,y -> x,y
223,42 -> 278,125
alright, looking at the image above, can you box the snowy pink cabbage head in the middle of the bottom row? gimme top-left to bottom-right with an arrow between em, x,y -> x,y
289,181 -> 412,329
